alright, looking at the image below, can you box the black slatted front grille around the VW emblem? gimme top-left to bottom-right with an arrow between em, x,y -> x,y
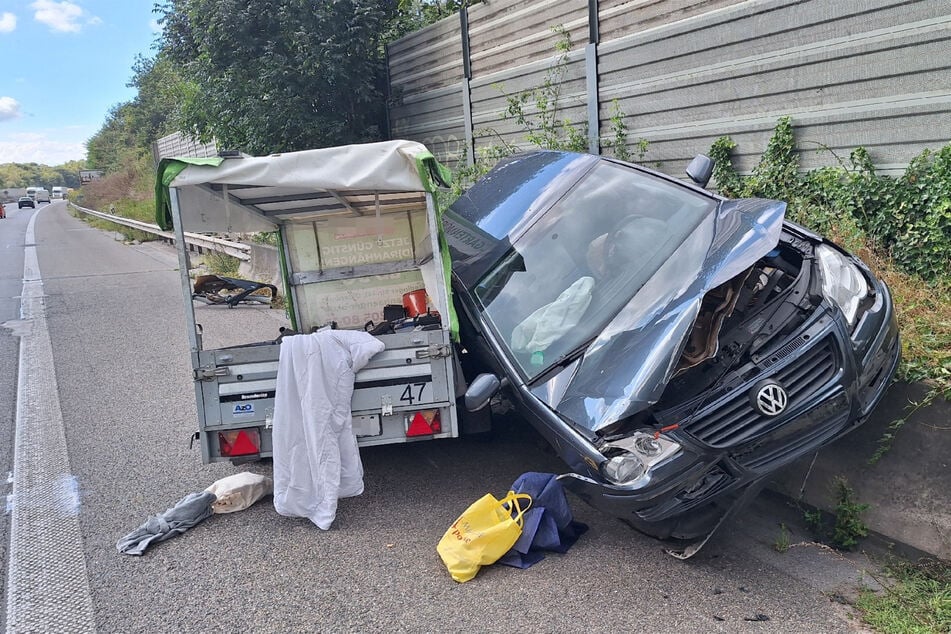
681,338 -> 838,448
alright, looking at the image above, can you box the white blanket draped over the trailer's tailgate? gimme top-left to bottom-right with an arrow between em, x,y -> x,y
271,330 -> 385,530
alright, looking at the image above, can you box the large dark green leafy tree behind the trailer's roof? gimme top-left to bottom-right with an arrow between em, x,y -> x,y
157,0 -> 398,154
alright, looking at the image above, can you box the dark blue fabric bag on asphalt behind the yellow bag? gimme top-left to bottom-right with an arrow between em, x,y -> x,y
498,471 -> 588,568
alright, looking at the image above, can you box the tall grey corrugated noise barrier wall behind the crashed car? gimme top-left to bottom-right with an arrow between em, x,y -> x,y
389,0 -> 951,174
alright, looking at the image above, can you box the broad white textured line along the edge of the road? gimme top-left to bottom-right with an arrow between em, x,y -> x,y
6,206 -> 96,634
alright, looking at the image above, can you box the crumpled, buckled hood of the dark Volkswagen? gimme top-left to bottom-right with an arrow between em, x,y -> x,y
532,199 -> 786,432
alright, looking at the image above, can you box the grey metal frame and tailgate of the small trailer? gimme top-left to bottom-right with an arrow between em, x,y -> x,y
168,148 -> 464,463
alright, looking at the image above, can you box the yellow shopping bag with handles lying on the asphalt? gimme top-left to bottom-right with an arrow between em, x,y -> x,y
436,491 -> 532,582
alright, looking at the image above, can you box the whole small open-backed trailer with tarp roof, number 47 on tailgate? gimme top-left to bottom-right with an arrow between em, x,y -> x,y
156,141 -> 465,463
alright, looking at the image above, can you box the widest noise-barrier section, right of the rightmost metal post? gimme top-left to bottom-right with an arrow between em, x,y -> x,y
599,0 -> 951,171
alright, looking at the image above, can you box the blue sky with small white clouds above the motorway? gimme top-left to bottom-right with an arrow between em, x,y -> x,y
0,0 -> 160,165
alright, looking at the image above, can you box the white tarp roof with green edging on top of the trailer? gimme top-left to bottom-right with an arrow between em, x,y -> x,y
156,141 -> 450,233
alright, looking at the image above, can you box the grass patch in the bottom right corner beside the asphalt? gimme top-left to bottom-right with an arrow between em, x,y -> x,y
855,560 -> 951,634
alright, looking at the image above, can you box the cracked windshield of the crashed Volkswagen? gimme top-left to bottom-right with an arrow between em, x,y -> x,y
474,162 -> 716,379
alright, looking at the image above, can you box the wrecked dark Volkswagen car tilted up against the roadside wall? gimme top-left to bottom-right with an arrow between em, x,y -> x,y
444,151 -> 900,557
